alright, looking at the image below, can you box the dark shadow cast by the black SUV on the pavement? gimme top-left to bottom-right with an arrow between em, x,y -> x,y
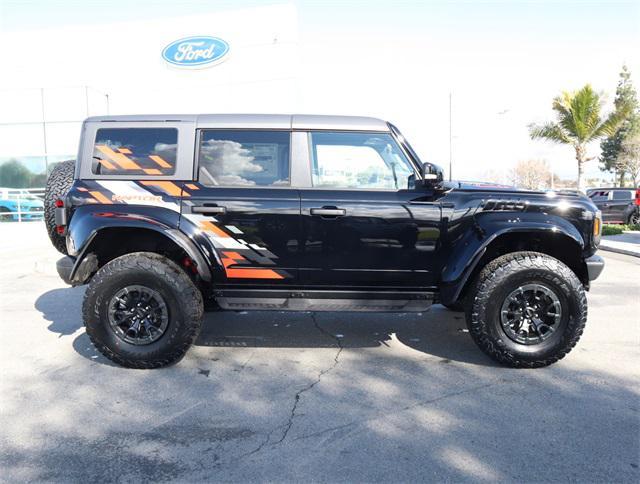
35,287 -> 494,366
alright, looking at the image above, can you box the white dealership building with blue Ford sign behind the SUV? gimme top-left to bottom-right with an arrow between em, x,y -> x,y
0,4 -> 299,183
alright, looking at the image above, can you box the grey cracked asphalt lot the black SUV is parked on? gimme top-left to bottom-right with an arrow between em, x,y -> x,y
0,223 -> 640,482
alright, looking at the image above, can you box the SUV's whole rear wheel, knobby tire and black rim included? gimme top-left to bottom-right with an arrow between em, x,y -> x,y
82,252 -> 203,368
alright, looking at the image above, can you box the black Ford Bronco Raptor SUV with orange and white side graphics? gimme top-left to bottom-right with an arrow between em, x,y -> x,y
46,115 -> 604,368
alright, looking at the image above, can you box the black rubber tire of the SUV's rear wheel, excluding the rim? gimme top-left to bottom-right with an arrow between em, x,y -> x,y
82,252 -> 203,369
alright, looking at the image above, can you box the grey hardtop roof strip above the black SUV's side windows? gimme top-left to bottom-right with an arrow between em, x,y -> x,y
85,114 -> 389,131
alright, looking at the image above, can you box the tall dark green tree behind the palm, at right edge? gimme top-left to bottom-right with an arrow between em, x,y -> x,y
600,66 -> 640,186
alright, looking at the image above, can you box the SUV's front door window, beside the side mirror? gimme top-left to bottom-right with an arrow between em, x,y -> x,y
310,131 -> 414,190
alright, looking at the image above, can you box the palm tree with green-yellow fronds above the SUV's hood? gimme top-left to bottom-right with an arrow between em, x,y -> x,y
529,84 -> 629,191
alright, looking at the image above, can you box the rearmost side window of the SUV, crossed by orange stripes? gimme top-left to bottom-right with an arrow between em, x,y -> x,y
91,128 -> 178,176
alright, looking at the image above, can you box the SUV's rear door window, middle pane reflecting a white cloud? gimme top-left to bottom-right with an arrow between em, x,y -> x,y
198,129 -> 291,186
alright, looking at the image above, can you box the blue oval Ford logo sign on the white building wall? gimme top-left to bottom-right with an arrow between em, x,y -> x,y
162,36 -> 229,67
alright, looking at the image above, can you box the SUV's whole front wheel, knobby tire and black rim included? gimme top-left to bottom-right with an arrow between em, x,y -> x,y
466,252 -> 587,368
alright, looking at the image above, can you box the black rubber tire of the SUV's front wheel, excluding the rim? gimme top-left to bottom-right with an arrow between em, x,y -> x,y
466,252 -> 587,368
